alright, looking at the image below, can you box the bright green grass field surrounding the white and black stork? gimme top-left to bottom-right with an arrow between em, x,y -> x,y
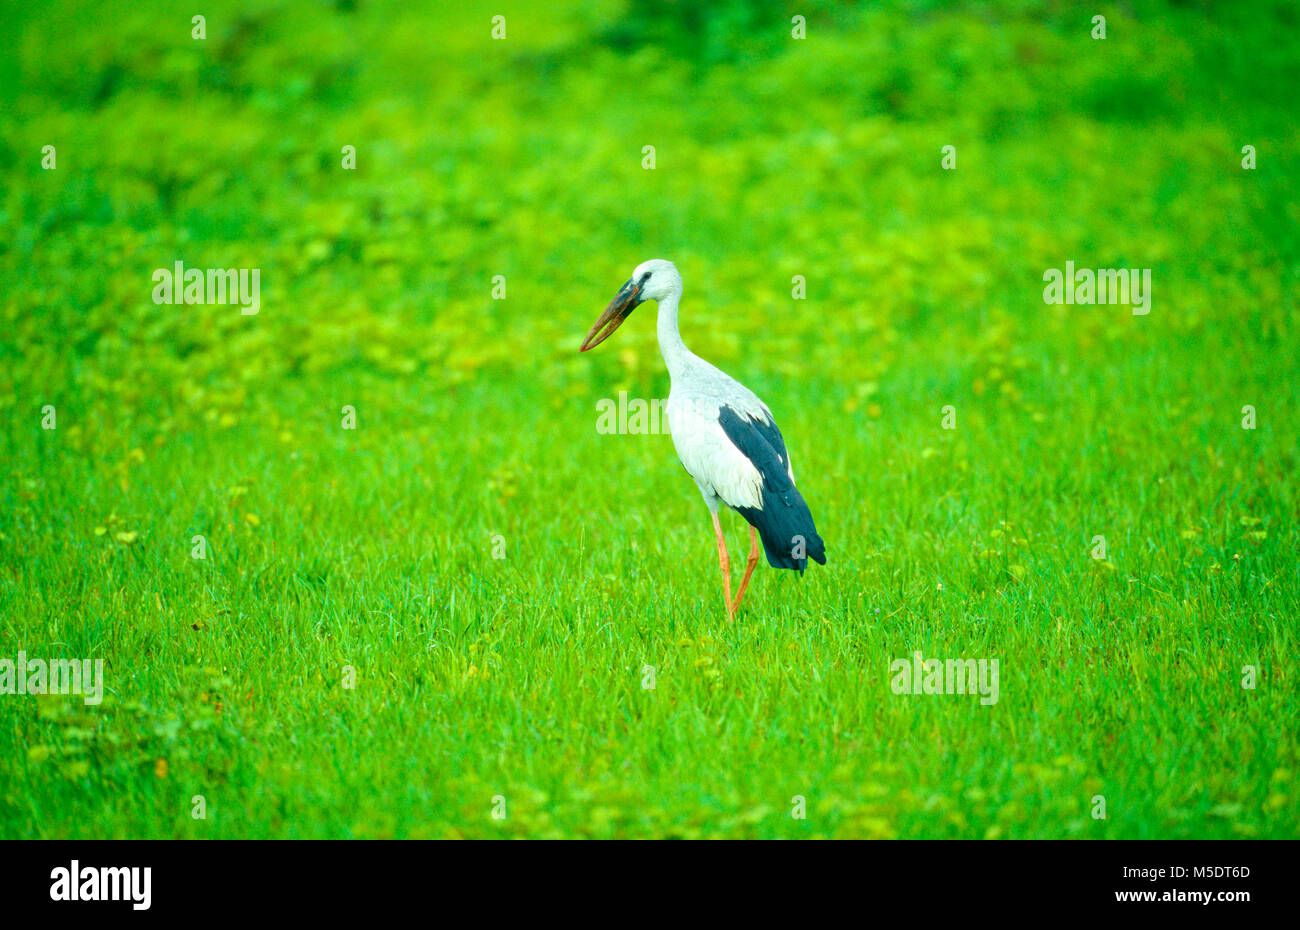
0,0 -> 1300,839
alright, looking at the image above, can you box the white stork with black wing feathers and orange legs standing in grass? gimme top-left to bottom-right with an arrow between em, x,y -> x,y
580,259 -> 826,620
